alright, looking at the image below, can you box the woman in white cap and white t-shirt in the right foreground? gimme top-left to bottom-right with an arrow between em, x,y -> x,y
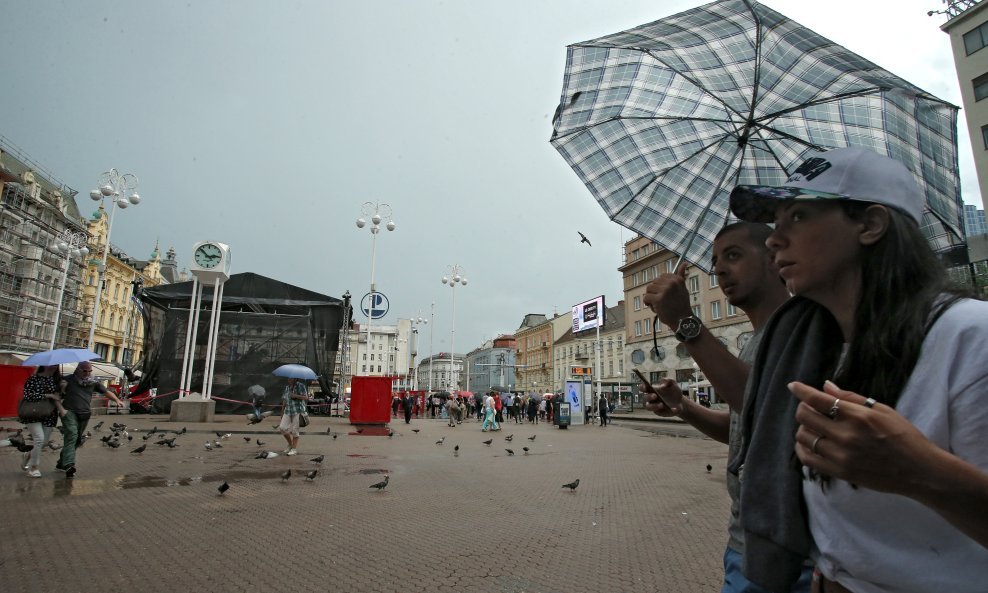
731,148 -> 988,593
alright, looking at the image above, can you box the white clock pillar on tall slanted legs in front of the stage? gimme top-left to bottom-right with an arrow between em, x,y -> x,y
171,241 -> 231,422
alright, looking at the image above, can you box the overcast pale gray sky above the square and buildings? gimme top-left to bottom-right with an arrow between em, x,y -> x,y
0,0 -> 982,354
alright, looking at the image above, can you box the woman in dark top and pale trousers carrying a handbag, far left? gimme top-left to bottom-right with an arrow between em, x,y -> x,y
17,365 -> 64,478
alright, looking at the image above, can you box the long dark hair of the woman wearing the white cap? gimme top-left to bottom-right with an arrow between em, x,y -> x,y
835,202 -> 966,407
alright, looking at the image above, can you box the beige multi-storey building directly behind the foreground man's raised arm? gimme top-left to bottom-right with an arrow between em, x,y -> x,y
618,237 -> 752,395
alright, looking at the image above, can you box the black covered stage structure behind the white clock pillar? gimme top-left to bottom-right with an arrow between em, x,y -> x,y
138,272 -> 344,414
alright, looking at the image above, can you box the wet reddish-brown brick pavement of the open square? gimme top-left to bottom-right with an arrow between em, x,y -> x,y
0,416 -> 729,593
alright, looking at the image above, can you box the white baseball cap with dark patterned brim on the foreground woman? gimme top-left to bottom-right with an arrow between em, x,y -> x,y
731,146 -> 926,224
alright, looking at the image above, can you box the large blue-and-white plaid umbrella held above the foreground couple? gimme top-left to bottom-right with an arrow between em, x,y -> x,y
551,0 -> 965,272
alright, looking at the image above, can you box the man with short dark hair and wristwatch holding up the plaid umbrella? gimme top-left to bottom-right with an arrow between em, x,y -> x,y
644,222 -> 812,593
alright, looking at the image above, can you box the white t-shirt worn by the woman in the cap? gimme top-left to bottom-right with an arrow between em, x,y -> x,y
803,300 -> 988,593
